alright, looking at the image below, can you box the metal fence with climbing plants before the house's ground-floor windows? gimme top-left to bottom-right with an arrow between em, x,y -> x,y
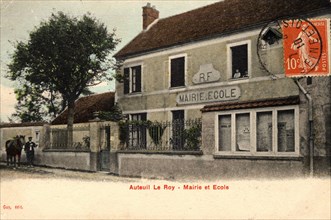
120,119 -> 201,151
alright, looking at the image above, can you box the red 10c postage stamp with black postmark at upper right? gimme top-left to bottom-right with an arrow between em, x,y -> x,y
282,19 -> 330,77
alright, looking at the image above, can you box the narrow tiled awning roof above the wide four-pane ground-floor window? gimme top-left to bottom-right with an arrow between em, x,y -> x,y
201,96 -> 300,112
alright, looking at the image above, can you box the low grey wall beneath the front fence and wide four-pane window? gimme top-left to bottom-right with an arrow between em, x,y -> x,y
118,153 -> 303,180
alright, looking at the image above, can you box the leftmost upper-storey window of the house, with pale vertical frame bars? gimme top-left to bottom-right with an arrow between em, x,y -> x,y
124,66 -> 141,94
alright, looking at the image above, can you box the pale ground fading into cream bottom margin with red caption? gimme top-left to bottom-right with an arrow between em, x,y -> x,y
0,164 -> 331,219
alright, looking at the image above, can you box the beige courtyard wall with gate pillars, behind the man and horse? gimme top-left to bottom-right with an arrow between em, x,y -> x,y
0,121 -> 119,171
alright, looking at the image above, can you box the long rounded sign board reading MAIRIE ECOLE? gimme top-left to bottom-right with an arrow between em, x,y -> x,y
176,86 -> 241,105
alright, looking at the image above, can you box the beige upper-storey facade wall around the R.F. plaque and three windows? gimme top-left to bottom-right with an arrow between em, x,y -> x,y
116,26 -> 299,124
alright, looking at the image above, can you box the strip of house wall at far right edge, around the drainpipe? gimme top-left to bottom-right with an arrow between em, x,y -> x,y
299,77 -> 331,175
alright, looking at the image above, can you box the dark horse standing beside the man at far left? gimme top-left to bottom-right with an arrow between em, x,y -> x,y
6,135 -> 25,167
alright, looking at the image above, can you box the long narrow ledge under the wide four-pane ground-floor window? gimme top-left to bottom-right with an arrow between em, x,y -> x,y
213,154 -> 303,161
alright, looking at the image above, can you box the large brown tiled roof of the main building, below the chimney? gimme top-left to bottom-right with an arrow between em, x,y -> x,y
115,0 -> 331,59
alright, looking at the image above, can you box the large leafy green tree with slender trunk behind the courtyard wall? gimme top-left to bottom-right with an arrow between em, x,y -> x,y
8,12 -> 120,146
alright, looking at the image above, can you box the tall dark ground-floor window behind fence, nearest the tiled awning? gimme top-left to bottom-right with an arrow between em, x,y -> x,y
171,110 -> 185,150
